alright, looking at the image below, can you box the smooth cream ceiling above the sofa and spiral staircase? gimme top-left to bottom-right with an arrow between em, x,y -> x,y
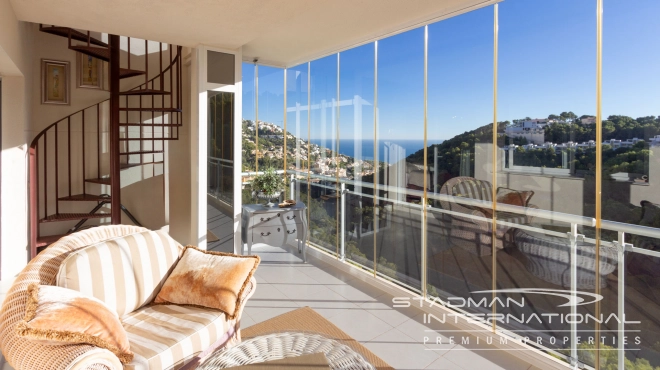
11,0 -> 492,66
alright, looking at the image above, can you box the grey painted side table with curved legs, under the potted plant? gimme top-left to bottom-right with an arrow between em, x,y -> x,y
241,202 -> 307,262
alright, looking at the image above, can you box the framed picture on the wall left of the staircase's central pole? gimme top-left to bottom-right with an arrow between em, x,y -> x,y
41,59 -> 71,105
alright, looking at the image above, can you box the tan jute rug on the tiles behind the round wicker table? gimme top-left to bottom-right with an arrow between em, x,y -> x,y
241,307 -> 394,370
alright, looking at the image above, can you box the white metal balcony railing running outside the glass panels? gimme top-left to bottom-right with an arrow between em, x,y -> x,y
270,170 -> 660,364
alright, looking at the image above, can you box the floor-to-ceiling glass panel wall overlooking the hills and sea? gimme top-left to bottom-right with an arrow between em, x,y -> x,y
243,0 -> 660,370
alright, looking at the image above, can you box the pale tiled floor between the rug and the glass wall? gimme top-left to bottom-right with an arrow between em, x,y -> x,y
237,244 -> 536,370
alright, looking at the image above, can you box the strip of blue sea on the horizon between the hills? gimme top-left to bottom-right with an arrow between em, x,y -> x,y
310,139 -> 443,162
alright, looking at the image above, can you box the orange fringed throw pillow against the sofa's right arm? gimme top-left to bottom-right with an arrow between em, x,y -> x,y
154,246 -> 260,320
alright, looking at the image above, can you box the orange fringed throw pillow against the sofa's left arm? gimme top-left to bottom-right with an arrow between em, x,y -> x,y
16,284 -> 133,364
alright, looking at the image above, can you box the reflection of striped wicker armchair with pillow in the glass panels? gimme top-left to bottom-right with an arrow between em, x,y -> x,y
434,176 -> 538,256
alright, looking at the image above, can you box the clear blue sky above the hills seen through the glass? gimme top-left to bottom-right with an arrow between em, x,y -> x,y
243,0 -> 660,140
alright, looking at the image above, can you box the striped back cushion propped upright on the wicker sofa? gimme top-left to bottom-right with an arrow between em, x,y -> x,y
55,230 -> 183,317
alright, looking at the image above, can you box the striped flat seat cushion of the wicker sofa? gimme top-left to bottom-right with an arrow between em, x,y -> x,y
122,305 -> 235,370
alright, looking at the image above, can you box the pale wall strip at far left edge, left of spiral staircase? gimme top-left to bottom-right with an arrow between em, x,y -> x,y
0,0 -> 31,281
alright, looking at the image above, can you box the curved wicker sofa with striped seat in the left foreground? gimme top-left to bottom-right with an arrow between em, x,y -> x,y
0,225 -> 256,370
